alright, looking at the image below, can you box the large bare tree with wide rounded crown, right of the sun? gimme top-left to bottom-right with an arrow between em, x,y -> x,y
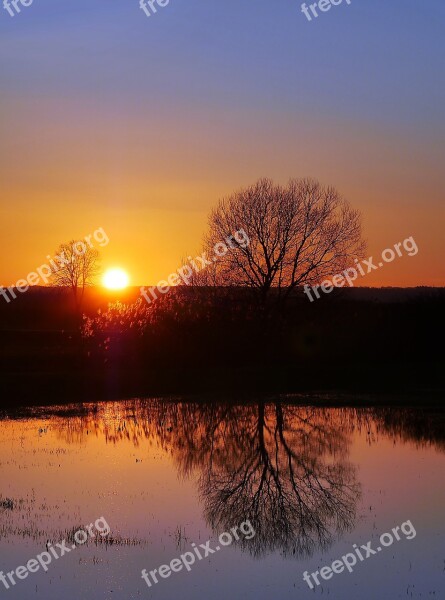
203,179 -> 366,297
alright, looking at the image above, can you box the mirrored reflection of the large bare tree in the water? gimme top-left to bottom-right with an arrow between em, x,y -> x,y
152,402 -> 359,556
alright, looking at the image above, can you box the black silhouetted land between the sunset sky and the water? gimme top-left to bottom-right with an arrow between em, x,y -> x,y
0,288 -> 445,405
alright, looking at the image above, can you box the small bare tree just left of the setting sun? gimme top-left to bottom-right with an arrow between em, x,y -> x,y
52,240 -> 99,312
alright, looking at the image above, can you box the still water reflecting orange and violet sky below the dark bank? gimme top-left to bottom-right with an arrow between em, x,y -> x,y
0,399 -> 445,600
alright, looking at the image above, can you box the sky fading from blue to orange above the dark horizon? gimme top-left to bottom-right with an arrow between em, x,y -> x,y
0,0 -> 445,286
